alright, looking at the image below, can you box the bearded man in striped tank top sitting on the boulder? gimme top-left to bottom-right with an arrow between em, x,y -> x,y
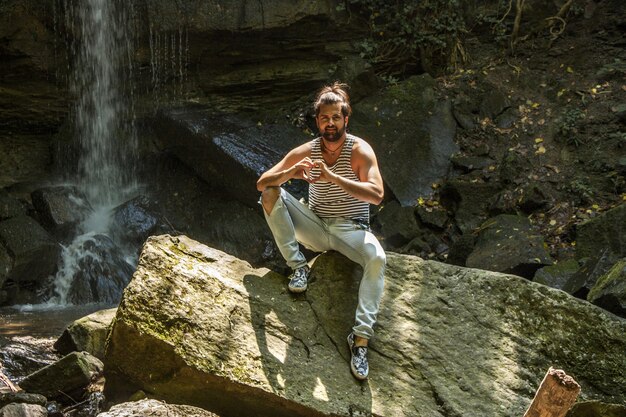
257,83 -> 385,380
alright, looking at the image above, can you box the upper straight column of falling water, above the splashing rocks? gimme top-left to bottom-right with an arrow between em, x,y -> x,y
70,0 -> 136,208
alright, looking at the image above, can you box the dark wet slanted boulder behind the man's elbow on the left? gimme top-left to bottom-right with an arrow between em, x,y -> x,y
156,109 -> 310,207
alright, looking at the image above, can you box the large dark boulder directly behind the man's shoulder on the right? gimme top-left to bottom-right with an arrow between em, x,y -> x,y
350,74 -> 458,206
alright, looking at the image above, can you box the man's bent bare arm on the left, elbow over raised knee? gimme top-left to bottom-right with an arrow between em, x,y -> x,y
256,143 -> 314,192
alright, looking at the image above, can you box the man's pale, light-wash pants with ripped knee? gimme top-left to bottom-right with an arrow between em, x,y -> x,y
263,188 -> 386,339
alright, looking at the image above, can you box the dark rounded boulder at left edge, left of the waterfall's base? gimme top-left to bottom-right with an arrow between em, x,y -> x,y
0,216 -> 61,282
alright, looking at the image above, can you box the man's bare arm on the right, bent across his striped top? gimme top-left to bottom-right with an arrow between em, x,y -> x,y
314,139 -> 385,205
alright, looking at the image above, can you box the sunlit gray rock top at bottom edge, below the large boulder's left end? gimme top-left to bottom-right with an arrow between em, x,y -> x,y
98,399 -> 219,417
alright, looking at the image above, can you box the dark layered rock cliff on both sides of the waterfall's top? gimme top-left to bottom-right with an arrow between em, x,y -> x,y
0,0 -> 366,187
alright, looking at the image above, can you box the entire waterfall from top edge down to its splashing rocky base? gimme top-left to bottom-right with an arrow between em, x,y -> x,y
39,0 -> 138,306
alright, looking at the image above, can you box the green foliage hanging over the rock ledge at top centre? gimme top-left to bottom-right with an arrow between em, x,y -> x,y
341,0 -> 466,80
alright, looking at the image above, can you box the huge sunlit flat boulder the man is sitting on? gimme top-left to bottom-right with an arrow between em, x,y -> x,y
104,235 -> 626,417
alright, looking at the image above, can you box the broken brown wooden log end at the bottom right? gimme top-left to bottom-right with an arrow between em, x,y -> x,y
524,367 -> 580,417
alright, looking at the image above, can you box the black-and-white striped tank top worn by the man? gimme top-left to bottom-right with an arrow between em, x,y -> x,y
309,134 -> 370,224
